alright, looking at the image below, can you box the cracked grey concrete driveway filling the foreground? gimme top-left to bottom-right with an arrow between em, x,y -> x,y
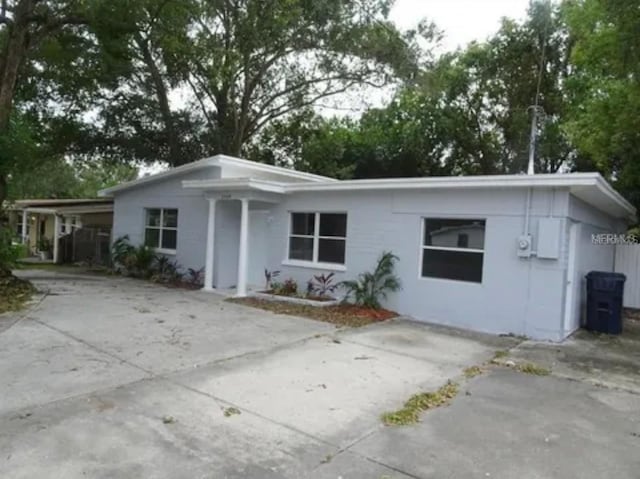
0,271 -> 640,479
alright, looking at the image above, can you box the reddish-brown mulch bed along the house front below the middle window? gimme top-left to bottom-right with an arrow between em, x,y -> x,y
227,298 -> 398,328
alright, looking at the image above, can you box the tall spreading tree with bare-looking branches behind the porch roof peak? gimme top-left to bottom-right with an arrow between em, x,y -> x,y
172,0 -> 418,155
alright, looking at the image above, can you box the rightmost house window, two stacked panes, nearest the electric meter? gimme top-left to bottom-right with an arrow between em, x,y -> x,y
422,218 -> 486,283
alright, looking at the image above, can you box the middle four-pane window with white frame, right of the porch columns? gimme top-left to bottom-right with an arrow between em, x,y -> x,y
289,213 -> 347,264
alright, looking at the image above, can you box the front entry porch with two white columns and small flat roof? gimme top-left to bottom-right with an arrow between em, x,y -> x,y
183,178 -> 283,297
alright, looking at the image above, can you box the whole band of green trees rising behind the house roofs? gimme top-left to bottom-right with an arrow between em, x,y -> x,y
0,0 -> 640,216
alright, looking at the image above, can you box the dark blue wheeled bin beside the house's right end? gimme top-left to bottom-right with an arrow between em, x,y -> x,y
585,271 -> 627,334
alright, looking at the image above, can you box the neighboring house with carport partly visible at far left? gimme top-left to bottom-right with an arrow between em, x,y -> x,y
9,198 -> 113,263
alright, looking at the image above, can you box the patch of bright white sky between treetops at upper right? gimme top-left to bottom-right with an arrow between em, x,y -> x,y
391,0 -> 529,51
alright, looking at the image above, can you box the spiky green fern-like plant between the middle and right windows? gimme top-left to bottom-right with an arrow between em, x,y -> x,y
340,251 -> 401,309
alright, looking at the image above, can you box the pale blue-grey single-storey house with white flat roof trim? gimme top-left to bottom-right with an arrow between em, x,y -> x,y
101,155 -> 636,340
